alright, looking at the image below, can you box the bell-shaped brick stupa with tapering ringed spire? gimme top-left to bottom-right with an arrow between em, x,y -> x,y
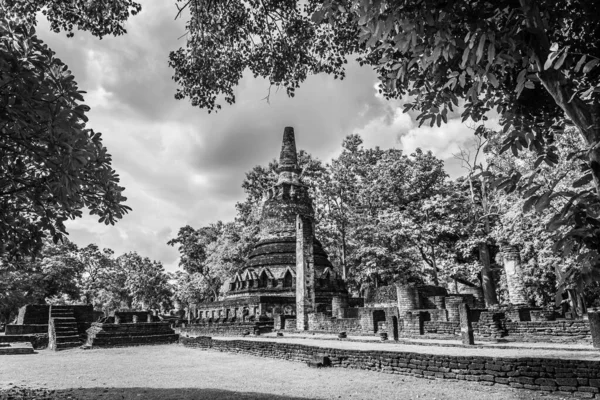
187,128 -> 347,334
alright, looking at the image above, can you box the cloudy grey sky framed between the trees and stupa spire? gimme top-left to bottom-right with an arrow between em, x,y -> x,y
37,0 -> 493,271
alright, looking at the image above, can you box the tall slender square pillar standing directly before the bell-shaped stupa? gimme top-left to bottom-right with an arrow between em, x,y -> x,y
296,214 -> 315,331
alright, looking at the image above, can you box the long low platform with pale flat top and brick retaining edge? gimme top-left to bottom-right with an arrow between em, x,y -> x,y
180,335 -> 600,398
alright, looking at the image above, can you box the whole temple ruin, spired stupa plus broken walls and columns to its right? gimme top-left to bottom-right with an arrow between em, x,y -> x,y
181,128 -> 591,344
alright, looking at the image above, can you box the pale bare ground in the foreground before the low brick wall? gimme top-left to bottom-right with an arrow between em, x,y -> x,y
0,345 -> 572,400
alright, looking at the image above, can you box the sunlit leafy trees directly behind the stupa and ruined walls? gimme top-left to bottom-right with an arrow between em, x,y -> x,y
169,130 -> 596,306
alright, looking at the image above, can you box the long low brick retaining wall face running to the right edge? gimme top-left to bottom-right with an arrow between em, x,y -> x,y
179,336 -> 600,398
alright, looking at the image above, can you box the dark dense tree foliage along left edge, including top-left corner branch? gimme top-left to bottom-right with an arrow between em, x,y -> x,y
0,0 -> 140,257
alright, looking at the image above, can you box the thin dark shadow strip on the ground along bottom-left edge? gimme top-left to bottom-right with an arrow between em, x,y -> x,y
0,387 -> 318,400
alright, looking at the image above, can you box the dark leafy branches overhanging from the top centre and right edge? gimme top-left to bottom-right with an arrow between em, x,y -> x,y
170,0 -> 600,276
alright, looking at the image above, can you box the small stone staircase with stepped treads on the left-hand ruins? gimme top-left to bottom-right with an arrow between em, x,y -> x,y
48,306 -> 82,351
